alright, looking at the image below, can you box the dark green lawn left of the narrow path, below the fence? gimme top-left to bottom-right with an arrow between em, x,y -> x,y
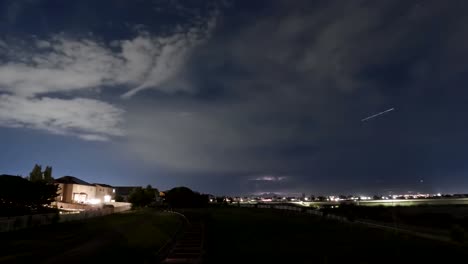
0,210 -> 181,263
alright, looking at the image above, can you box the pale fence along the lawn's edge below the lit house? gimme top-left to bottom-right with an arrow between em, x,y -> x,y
0,203 -> 131,232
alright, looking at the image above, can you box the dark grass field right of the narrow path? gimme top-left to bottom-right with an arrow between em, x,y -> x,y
206,208 -> 468,263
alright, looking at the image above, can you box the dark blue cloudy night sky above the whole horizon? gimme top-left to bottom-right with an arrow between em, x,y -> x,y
0,0 -> 468,195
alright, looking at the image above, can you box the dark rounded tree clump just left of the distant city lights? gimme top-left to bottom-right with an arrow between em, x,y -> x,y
165,187 -> 209,208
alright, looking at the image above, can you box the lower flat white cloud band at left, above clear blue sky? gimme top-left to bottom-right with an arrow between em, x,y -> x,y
0,94 -> 125,141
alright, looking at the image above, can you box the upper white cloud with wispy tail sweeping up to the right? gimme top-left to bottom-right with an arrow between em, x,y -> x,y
0,15 -> 214,98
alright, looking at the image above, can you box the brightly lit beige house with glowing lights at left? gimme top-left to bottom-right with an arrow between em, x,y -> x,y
54,176 -> 115,204
